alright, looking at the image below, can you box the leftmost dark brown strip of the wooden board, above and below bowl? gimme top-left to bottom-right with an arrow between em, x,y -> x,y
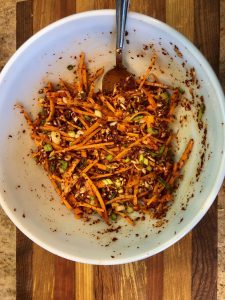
16,1 -> 33,300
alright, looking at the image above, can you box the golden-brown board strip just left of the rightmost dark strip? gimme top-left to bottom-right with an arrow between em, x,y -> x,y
163,0 -> 194,300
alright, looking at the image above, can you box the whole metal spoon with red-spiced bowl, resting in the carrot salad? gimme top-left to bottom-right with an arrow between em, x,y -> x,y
102,0 -> 134,93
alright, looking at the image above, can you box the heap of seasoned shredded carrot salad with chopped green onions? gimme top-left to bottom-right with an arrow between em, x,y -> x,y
17,53 -> 194,225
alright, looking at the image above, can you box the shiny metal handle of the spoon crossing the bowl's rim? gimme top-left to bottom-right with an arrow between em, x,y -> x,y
116,0 -> 130,66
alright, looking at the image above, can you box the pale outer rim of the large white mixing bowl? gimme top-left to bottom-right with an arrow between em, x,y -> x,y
0,9 -> 225,265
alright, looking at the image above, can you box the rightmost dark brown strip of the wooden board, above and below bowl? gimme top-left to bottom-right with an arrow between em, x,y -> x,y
192,0 -> 220,300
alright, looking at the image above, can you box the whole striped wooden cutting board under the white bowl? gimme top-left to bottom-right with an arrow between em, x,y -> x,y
16,0 -> 220,300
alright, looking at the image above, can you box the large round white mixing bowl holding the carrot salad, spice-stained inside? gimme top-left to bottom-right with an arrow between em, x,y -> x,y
0,10 -> 225,265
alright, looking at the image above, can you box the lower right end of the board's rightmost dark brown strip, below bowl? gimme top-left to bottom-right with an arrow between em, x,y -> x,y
192,205 -> 218,300
